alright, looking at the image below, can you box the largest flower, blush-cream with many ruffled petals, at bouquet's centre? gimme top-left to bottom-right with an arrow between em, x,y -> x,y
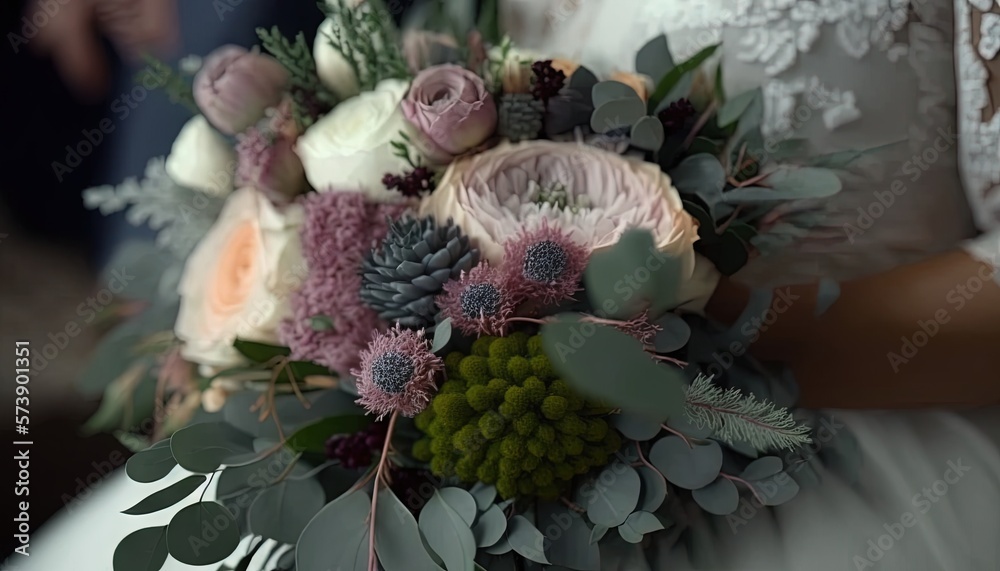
420,141 -> 698,277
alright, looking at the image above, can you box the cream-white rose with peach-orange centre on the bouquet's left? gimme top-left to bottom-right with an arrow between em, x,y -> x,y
174,188 -> 306,367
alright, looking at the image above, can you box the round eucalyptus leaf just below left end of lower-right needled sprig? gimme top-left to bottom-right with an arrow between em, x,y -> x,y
649,436 -> 722,490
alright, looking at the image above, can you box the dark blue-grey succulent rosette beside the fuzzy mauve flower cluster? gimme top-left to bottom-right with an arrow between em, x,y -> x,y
361,216 -> 479,328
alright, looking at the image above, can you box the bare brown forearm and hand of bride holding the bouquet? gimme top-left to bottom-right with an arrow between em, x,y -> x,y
706,251 -> 1000,409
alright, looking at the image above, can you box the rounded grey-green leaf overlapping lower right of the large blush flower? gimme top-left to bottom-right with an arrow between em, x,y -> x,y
584,230 -> 680,319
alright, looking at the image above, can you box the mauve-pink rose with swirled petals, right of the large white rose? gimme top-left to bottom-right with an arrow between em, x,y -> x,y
402,64 -> 497,164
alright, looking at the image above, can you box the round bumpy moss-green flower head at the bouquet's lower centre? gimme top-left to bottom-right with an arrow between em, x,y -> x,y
413,332 -> 621,499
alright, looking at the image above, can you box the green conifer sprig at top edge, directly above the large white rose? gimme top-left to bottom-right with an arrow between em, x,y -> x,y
320,0 -> 410,91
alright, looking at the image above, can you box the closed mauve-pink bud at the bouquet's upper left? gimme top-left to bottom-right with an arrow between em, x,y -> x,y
194,45 -> 290,135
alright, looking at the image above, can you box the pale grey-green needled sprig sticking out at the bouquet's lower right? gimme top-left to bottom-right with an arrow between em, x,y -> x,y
685,375 -> 812,452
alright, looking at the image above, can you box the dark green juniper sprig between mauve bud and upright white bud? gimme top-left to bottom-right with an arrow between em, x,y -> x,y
257,26 -> 337,128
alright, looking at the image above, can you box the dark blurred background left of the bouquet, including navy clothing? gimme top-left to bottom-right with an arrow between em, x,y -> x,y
0,0 -> 412,558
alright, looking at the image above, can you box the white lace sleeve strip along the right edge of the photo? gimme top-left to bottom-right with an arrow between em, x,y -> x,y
955,0 -> 1000,272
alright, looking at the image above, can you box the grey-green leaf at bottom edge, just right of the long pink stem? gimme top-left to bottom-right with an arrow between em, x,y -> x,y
375,488 -> 444,571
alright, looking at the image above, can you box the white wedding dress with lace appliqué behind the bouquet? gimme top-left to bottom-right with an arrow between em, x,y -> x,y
12,0 -> 1000,571
